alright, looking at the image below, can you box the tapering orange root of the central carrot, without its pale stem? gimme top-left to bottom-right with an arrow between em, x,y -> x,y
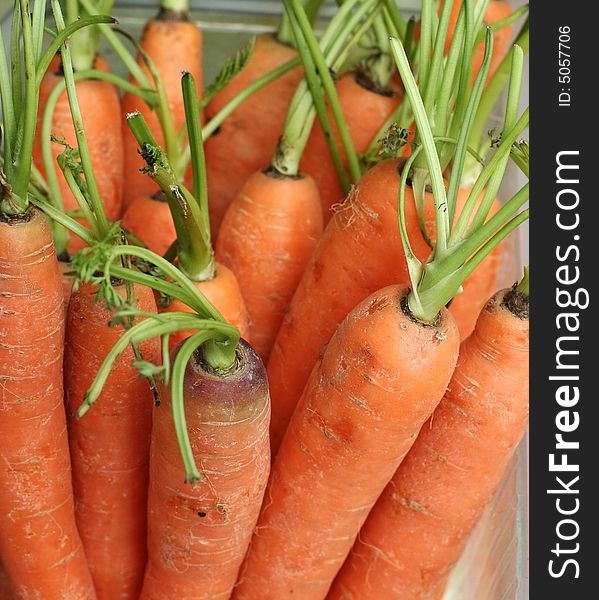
216,171 -> 322,362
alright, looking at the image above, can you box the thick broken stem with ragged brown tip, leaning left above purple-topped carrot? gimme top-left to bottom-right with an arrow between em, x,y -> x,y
127,112 -> 214,281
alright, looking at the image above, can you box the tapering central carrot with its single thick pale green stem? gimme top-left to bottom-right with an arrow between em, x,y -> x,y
216,2 -> 380,361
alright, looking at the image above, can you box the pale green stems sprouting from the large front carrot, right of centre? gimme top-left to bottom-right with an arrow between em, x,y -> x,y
391,27 -> 529,323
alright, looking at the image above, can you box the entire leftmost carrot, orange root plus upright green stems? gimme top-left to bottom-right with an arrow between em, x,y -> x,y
0,2 -> 95,600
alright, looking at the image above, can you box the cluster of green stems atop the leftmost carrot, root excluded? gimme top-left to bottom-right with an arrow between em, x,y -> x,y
0,0 -> 113,216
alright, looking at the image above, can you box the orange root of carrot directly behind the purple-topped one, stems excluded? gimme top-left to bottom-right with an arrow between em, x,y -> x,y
162,262 -> 250,350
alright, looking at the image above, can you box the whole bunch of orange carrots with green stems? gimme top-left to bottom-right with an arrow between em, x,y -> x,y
0,0 -> 529,600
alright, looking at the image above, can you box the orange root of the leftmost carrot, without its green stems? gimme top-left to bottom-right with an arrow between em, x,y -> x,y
0,210 -> 96,600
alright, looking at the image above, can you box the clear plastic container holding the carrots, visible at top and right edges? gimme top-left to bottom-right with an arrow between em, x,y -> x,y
0,0 -> 528,600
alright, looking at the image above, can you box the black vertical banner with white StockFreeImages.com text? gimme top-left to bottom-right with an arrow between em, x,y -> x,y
529,0 -> 599,600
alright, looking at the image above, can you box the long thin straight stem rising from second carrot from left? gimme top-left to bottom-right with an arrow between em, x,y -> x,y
52,0 -> 110,239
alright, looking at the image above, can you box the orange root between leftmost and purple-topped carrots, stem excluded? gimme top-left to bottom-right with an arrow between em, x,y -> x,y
65,284 -> 160,600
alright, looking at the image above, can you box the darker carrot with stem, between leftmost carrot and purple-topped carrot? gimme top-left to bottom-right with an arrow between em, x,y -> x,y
37,2 -> 164,599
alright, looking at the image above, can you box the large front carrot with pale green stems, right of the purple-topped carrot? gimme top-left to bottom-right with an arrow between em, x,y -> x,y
233,34 -> 527,600
